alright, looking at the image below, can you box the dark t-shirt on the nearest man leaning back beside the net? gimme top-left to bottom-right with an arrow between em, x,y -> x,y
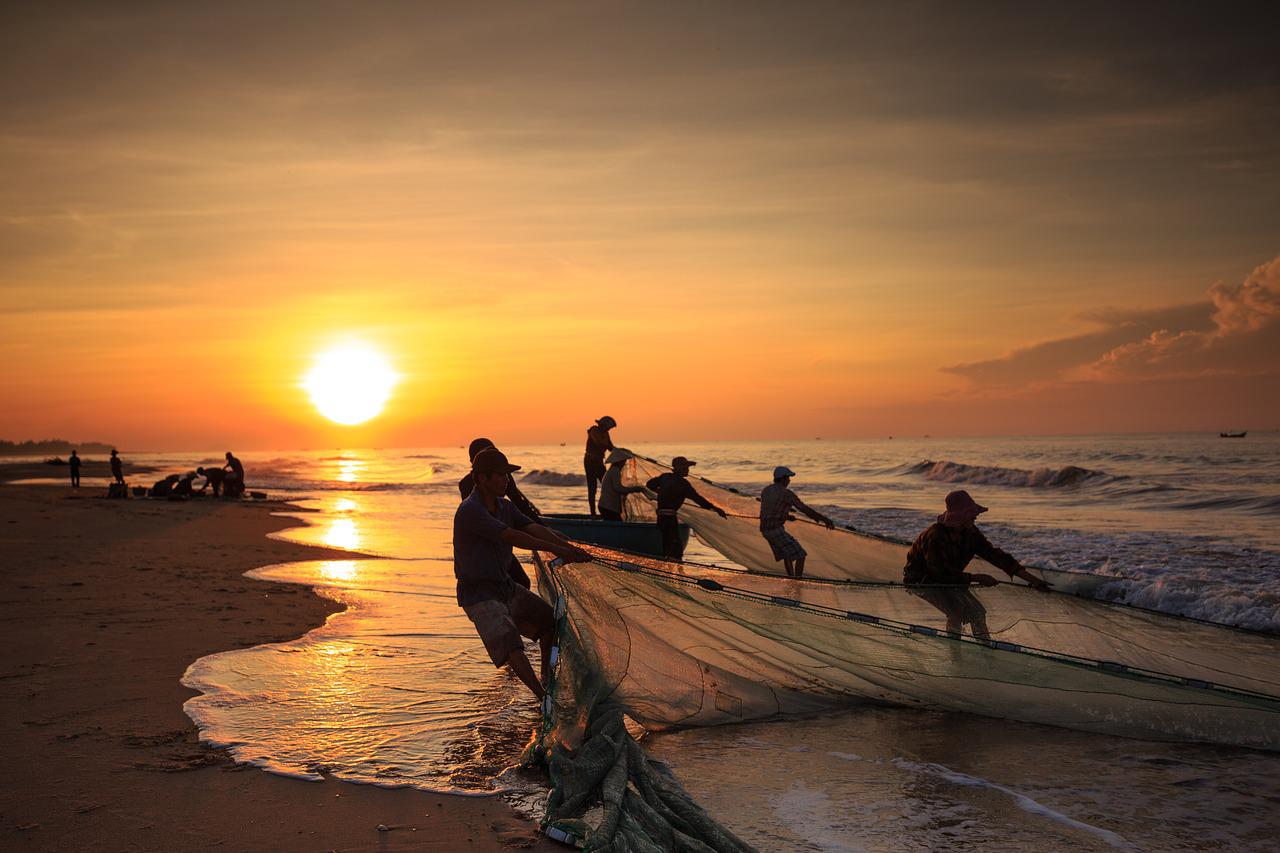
453,492 -> 532,607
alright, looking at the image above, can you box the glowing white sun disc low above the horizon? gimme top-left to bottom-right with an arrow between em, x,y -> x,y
302,343 -> 399,427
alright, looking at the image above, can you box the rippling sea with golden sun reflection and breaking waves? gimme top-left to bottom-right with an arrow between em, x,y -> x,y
40,429 -> 1280,850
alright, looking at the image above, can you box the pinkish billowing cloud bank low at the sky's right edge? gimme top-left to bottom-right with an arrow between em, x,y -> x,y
942,257 -> 1280,388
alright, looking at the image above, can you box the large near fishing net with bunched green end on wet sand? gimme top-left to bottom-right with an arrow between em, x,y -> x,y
527,548 -> 1280,850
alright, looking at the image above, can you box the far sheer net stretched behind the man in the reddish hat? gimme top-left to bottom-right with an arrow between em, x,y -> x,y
622,456 -> 1116,596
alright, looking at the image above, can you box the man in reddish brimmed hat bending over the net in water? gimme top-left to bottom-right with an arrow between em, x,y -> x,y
902,489 -> 1052,639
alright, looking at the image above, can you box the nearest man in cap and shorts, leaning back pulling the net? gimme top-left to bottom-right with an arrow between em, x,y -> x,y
453,447 -> 591,699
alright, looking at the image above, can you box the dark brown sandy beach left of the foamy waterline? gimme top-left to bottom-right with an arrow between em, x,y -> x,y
0,479 -> 562,850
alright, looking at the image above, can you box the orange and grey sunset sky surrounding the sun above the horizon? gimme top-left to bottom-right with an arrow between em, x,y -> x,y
0,3 -> 1280,450
